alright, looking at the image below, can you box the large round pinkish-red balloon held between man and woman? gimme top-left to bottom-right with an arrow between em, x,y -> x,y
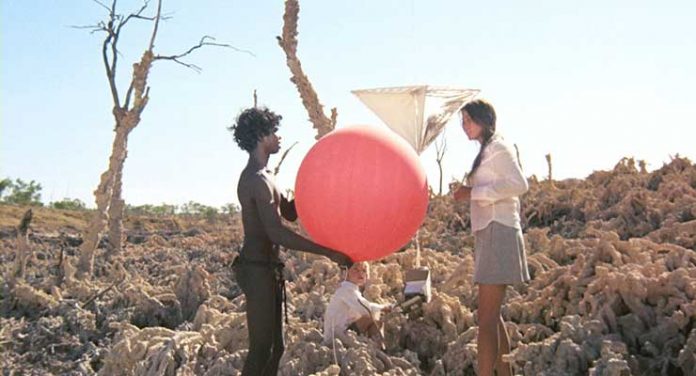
295,126 -> 428,261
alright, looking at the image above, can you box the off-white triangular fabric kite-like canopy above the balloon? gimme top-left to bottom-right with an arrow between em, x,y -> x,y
352,85 -> 479,154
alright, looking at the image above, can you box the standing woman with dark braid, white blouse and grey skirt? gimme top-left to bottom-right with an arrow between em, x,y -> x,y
454,100 -> 529,376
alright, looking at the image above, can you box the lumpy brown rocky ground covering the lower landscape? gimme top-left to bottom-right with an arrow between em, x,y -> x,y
0,157 -> 696,376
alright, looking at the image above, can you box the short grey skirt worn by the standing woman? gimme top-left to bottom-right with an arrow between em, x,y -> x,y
474,222 -> 529,285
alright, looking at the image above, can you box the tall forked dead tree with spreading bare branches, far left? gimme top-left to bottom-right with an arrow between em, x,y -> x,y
77,0 -> 237,278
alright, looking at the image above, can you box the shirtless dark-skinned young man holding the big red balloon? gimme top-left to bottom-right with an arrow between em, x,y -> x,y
230,108 -> 352,376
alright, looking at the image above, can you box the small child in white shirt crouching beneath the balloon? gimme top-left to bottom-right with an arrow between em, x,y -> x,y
324,261 -> 392,347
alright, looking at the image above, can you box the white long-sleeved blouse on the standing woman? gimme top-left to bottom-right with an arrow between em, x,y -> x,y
469,135 -> 529,232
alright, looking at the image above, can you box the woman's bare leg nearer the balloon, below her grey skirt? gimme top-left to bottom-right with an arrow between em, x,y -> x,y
477,284 -> 505,376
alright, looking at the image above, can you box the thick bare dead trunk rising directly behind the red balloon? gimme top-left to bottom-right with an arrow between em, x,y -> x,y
276,0 -> 338,139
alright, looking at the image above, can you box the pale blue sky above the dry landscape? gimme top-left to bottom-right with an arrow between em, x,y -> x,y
0,0 -> 696,206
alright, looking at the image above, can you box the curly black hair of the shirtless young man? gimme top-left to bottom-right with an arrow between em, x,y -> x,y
228,107 -> 283,153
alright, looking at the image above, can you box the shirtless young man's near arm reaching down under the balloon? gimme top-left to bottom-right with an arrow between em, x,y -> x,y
252,177 -> 351,265
